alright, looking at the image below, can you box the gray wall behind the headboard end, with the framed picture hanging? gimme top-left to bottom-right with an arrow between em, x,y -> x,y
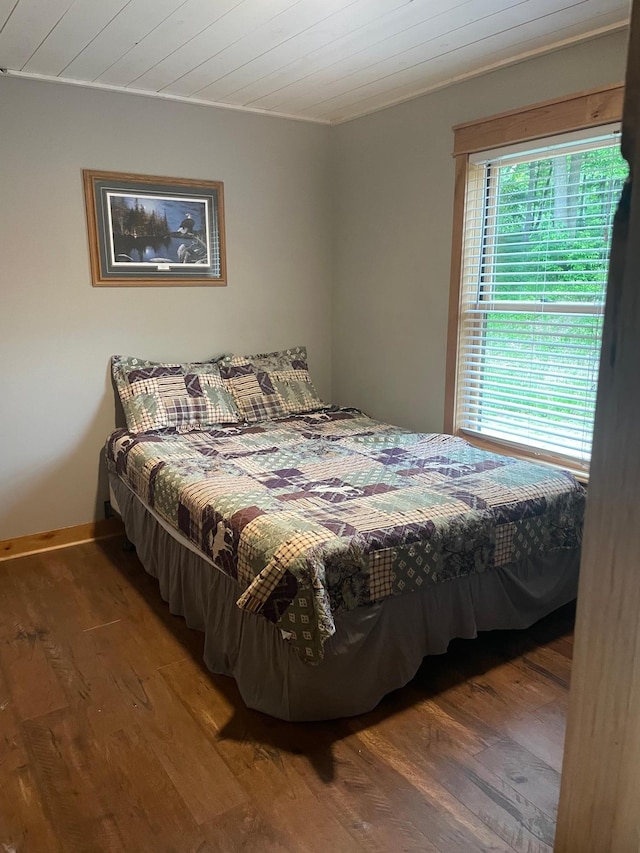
0,78 -> 331,539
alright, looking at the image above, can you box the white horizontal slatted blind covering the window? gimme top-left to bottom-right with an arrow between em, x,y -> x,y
456,129 -> 627,469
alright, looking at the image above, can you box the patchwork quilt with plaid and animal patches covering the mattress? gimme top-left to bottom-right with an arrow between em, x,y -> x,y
107,408 -> 585,663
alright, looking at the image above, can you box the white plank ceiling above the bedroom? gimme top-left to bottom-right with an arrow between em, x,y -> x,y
0,0 -> 629,123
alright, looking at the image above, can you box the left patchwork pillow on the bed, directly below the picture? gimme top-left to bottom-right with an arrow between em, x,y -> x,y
111,355 -> 240,433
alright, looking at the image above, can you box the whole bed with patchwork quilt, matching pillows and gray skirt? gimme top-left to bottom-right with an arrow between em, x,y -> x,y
106,348 -> 585,720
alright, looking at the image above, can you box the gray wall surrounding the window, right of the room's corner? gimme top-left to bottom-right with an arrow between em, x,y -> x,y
332,33 -> 627,432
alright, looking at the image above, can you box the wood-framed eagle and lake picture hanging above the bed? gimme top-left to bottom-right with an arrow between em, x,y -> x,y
83,169 -> 227,287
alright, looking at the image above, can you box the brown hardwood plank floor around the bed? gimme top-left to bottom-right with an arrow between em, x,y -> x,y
0,539 -> 574,853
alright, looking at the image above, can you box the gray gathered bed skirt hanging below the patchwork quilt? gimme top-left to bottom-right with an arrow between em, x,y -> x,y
110,475 -> 580,720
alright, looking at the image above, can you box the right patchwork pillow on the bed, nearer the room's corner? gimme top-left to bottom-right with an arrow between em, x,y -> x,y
220,347 -> 324,421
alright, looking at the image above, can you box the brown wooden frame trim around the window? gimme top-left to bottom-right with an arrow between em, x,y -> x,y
444,83 -> 624,479
